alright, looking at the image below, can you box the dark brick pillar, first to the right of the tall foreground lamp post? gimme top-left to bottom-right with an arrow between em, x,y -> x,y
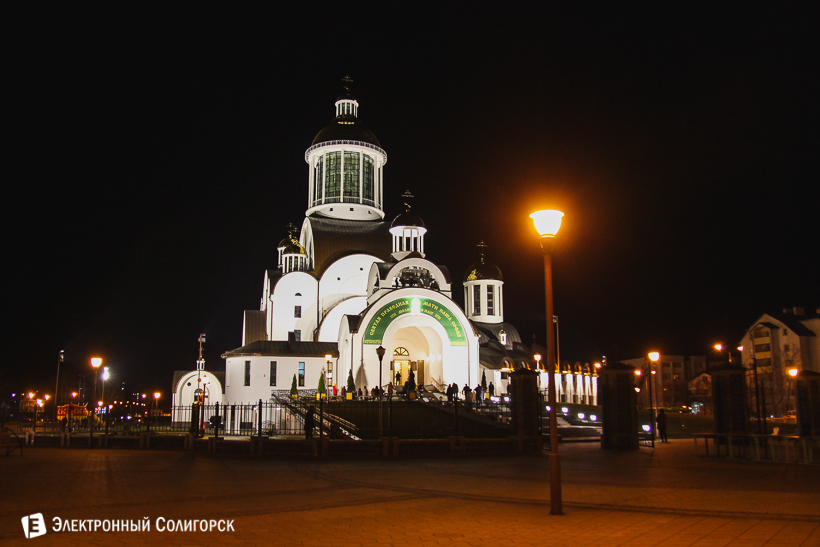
598,363 -> 638,450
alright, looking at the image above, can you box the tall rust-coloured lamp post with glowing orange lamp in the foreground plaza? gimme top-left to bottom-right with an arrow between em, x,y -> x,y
530,210 -> 564,515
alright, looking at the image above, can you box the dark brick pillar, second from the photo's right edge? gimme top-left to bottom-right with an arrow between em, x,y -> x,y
706,365 -> 749,435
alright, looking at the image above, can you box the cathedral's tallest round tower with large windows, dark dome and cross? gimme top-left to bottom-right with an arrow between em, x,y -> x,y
305,76 -> 387,221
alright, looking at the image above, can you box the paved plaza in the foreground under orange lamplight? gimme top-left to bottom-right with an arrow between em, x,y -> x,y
0,440 -> 820,547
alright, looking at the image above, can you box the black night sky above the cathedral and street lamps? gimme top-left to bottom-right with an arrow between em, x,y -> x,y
0,3 -> 820,398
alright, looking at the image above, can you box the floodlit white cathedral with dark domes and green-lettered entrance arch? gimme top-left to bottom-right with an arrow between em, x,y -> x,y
173,80 -> 589,405
